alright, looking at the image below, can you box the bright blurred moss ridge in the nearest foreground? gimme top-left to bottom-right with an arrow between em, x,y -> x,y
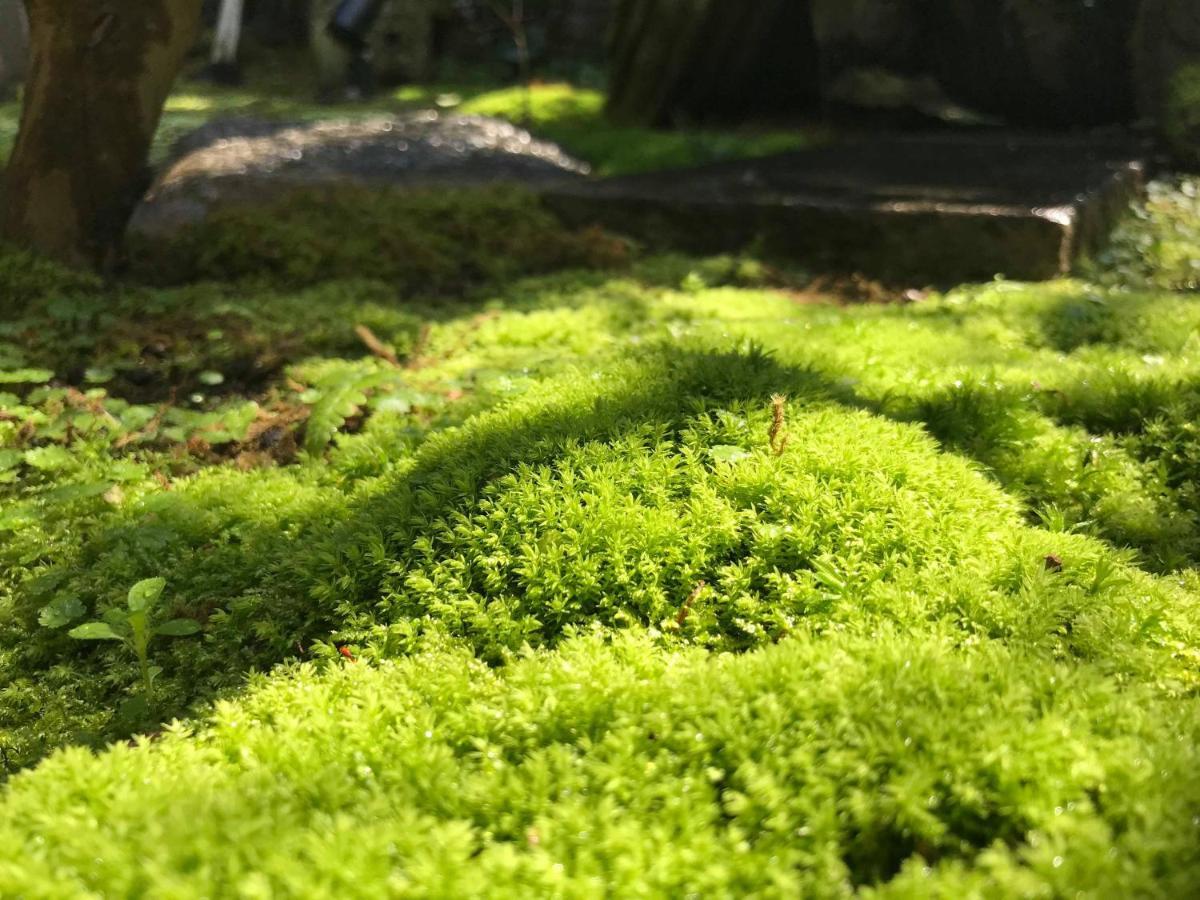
0,630 -> 1200,896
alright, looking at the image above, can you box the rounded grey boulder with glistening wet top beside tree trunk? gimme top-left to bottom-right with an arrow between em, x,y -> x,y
132,110 -> 588,234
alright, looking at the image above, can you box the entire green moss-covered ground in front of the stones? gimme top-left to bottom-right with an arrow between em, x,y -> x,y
0,81 -> 1200,898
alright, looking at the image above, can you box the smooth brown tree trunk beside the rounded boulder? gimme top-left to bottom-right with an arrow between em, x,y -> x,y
4,0 -> 200,268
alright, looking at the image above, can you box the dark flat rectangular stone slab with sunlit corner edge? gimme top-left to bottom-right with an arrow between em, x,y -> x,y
545,133 -> 1145,283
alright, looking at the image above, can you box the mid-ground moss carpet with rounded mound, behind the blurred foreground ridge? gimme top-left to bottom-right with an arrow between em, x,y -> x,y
7,260 -> 1200,762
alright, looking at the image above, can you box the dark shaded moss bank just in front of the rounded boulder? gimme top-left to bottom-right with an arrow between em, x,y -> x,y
132,186 -> 626,290
